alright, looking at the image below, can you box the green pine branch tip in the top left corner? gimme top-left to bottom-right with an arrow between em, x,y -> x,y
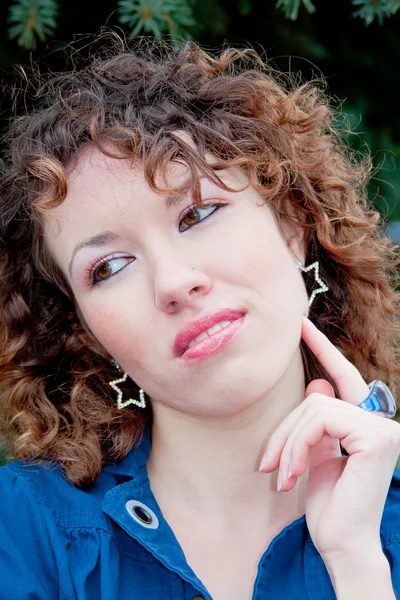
7,0 -> 59,50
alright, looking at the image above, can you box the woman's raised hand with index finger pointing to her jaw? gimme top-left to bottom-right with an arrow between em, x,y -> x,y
262,318 -> 400,564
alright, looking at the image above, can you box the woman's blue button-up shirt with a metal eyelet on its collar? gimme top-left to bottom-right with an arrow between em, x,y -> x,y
0,422 -> 400,600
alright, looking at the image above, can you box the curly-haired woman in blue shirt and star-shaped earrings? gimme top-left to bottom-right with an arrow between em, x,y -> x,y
0,37 -> 400,600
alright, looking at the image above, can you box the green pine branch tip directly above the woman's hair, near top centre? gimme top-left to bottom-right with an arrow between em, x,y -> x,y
118,0 -> 196,39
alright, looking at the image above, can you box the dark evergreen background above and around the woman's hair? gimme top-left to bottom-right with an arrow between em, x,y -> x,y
0,0 -> 400,462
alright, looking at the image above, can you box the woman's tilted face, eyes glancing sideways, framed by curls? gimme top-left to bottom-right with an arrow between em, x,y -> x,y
45,149 -> 308,417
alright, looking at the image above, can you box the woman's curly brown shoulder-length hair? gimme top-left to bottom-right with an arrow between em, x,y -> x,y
0,34 -> 400,487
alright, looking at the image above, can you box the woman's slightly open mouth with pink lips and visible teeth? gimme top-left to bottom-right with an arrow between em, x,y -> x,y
174,309 -> 245,358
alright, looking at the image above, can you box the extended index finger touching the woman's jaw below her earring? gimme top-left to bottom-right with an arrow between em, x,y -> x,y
301,317 -> 369,405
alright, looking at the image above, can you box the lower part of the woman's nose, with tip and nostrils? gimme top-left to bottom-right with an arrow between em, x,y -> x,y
154,257 -> 211,313
